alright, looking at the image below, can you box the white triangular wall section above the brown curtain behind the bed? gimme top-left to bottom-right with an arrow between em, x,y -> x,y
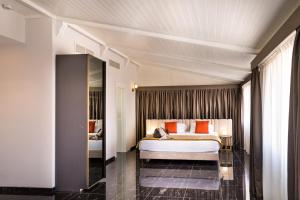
138,66 -> 229,86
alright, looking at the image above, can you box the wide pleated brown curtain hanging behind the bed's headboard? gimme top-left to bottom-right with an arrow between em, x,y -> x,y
136,85 -> 244,149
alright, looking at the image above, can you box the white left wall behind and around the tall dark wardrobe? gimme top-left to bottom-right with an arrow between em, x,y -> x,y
0,18 -> 137,188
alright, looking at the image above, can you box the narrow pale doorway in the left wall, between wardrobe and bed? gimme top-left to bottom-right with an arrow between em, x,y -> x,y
116,87 -> 126,152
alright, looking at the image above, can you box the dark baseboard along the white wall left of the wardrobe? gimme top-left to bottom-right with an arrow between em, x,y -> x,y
0,187 -> 55,196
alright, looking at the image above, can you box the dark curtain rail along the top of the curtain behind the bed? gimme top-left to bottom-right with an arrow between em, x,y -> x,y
137,84 -> 240,91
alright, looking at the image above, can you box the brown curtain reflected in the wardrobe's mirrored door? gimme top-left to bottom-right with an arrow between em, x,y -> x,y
89,89 -> 103,119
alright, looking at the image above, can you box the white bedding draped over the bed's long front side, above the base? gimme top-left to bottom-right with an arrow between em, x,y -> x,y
139,140 -> 220,153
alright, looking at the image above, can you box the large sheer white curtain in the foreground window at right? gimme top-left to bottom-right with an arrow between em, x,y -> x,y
261,34 -> 295,200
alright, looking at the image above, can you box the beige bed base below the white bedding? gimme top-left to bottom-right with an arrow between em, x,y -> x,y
140,151 -> 219,161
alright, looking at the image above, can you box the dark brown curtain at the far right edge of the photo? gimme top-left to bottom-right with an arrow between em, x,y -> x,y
288,28 -> 300,200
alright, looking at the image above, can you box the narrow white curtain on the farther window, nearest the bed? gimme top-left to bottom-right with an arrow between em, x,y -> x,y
242,81 -> 251,154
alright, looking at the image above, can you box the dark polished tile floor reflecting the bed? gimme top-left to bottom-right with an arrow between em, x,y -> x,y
0,151 -> 249,200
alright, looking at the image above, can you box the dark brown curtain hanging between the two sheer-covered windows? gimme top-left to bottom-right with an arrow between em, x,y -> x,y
250,67 -> 263,200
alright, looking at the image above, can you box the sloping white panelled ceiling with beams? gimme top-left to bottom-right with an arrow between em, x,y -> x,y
9,0 -> 300,83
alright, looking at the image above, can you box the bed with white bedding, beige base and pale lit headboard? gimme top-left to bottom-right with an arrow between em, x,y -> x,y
139,119 -> 232,161
